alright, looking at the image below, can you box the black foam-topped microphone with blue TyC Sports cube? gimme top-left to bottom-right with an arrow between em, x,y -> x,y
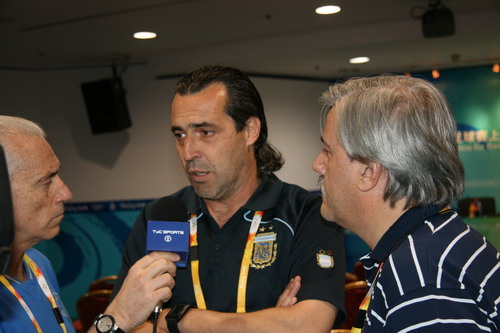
146,196 -> 189,319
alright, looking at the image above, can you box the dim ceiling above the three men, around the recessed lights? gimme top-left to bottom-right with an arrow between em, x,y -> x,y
0,0 -> 500,79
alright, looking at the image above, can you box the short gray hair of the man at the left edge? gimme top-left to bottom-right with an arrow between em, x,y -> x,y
0,115 -> 46,177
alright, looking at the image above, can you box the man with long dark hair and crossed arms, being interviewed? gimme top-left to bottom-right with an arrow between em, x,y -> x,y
115,66 -> 345,333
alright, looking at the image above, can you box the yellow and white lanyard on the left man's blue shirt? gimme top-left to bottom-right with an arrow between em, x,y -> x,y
0,254 -> 66,333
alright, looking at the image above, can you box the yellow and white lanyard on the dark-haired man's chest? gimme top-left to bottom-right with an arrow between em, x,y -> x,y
189,210 -> 264,313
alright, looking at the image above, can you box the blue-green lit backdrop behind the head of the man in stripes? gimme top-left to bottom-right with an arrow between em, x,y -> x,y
420,66 -> 500,213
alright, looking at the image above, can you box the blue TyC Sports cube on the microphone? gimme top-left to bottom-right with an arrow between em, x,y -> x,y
146,221 -> 189,267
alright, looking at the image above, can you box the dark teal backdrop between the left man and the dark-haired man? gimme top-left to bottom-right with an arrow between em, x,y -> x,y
36,200 -> 150,319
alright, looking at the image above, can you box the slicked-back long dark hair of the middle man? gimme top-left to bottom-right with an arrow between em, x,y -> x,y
175,65 -> 284,179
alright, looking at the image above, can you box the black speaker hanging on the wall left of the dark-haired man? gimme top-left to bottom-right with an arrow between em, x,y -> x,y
81,77 -> 132,134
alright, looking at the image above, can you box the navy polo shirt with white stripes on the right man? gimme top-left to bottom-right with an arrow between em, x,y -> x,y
361,207 -> 500,333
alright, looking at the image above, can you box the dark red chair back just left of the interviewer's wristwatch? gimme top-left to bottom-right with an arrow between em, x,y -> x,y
76,289 -> 112,332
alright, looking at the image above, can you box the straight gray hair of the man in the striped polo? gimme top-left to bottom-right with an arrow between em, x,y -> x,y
321,75 -> 464,209
